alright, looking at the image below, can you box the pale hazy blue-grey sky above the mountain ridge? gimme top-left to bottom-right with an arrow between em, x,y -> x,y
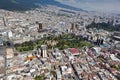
56,0 -> 120,13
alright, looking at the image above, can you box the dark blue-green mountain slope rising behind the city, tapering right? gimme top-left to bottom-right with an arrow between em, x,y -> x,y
0,0 -> 84,11
